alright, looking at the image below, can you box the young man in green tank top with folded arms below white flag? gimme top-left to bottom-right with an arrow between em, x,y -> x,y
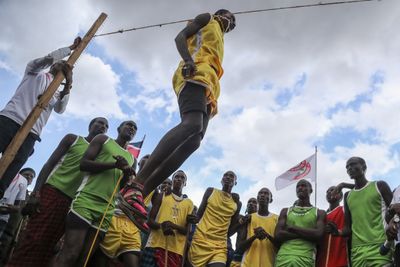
275,180 -> 326,267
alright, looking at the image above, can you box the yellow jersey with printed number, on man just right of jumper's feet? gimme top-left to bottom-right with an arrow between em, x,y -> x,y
146,194 -> 193,255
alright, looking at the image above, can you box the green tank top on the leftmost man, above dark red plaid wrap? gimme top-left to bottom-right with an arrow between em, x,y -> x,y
46,136 -> 89,199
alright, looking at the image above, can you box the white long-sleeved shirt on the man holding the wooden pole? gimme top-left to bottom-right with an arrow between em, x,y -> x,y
0,47 -> 71,136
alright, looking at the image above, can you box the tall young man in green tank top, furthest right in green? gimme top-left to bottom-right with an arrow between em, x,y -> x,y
332,157 -> 393,267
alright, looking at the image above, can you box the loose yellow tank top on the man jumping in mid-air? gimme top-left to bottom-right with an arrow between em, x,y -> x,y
172,16 -> 224,116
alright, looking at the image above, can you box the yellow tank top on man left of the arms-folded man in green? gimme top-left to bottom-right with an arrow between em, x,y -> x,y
241,213 -> 278,267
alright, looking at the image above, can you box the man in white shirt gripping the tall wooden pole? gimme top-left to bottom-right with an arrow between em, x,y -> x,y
0,37 -> 81,198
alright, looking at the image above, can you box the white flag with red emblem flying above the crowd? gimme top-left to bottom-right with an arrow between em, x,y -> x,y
275,154 -> 316,190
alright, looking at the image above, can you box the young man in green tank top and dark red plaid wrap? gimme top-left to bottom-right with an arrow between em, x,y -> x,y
9,117 -> 108,266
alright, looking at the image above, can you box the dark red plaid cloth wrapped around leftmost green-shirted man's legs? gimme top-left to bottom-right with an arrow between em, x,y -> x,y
7,184 -> 72,267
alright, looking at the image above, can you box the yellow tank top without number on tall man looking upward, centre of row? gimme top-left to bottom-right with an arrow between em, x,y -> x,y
193,188 -> 237,248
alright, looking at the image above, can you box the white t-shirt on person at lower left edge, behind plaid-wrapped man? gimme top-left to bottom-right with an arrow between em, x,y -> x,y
0,174 -> 28,222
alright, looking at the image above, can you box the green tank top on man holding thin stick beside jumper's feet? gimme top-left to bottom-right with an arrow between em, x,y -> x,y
78,138 -> 134,204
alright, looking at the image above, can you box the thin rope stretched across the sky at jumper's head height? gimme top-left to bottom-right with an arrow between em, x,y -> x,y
94,0 -> 382,37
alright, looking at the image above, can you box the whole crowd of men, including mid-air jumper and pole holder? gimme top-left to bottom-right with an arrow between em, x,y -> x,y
0,9 -> 400,267
